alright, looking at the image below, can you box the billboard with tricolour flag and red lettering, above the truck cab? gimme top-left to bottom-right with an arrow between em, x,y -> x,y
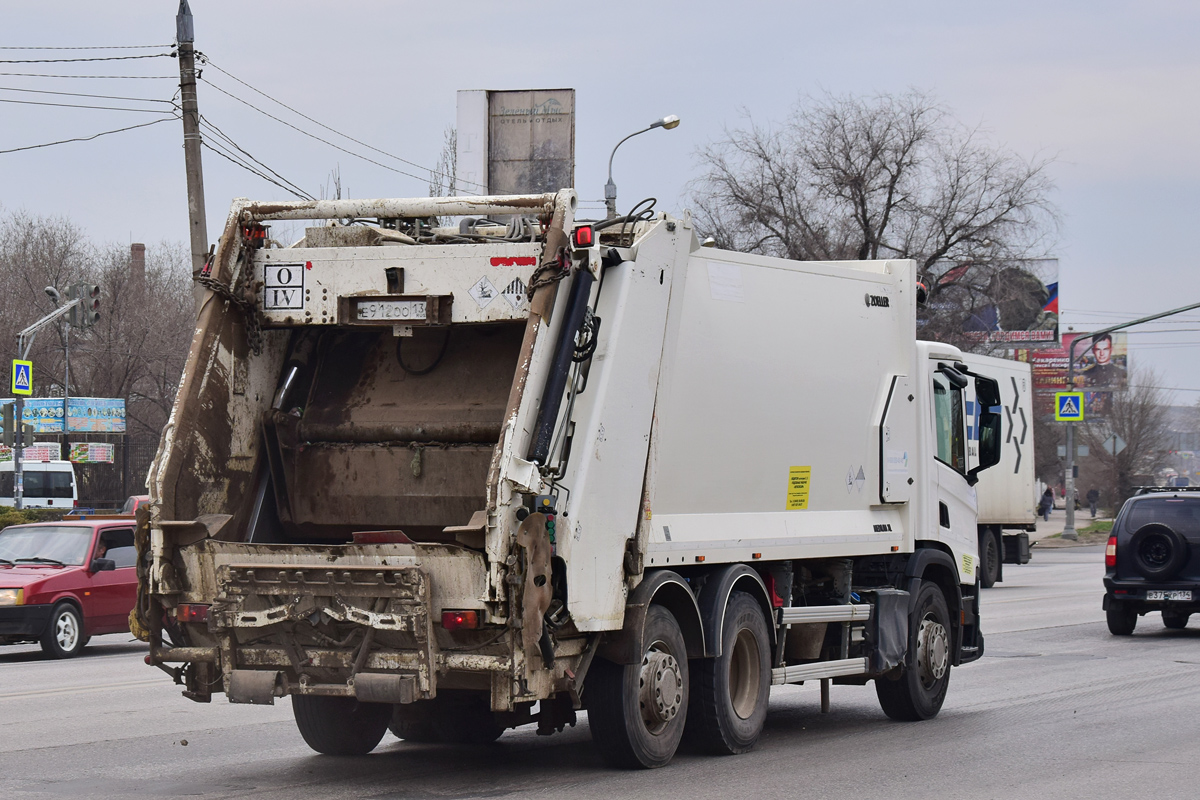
955,258 -> 1058,347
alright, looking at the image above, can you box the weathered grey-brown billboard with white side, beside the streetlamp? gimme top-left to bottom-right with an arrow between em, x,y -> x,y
455,89 -> 575,194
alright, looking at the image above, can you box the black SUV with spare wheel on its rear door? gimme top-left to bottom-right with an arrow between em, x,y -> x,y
1104,487 -> 1200,636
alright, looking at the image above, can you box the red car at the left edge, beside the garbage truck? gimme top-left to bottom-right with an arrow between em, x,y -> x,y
0,519 -> 138,658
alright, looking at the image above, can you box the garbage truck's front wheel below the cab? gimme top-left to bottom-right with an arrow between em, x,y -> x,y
875,581 -> 950,722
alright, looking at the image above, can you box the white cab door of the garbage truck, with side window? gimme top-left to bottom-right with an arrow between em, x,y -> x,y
931,362 -> 978,582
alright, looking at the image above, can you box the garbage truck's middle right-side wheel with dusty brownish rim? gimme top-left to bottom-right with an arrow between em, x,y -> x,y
686,591 -> 770,754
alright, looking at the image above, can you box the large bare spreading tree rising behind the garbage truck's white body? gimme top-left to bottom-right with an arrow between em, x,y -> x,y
692,91 -> 1057,344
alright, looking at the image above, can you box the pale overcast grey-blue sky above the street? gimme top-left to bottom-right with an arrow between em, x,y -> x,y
7,0 -> 1200,404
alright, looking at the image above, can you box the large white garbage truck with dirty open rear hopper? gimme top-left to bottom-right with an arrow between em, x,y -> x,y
134,191 -> 1001,768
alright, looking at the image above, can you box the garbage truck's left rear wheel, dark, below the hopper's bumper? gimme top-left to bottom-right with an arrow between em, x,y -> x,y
292,694 -> 391,756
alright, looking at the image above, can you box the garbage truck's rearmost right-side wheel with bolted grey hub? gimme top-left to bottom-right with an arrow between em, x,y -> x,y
584,606 -> 688,769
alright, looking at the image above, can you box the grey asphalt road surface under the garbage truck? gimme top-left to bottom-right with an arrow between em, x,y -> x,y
0,547 -> 1200,800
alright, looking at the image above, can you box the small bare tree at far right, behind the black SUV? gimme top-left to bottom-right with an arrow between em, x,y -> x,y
1082,368 -> 1170,509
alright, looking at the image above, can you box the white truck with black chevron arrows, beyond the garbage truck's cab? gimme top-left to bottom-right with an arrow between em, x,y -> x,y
962,353 -> 1038,589
